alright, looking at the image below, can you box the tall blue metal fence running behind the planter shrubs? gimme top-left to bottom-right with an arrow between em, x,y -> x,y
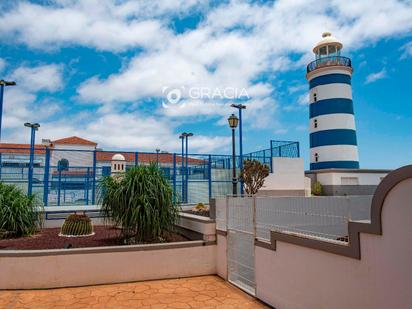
0,141 -> 295,206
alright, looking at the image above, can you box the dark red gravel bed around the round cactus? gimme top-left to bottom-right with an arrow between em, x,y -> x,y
0,225 -> 189,250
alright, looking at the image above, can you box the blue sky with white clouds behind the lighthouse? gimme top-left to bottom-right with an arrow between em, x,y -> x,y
0,0 -> 412,168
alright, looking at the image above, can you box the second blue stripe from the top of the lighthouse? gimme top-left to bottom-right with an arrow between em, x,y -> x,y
309,98 -> 353,118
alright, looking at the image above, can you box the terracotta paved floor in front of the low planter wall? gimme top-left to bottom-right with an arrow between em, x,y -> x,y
0,276 -> 264,309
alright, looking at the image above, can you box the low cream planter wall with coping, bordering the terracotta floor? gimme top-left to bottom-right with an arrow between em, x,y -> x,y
0,241 -> 216,289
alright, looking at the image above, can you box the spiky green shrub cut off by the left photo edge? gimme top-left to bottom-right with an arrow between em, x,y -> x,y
0,182 -> 41,237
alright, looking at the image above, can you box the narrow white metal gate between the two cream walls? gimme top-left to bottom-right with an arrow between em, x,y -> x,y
226,197 -> 256,295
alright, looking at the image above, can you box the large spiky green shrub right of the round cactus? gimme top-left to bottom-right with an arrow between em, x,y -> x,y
101,164 -> 178,242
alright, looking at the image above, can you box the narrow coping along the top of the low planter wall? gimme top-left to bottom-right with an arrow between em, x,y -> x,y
0,240 -> 216,258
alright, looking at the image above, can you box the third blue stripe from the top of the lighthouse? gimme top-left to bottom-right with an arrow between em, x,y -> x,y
310,129 -> 357,148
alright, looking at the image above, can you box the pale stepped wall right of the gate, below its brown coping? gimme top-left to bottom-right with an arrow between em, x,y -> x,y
255,179 -> 412,309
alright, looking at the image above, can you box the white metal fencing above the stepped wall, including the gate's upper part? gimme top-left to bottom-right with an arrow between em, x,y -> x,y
216,196 -> 372,242
